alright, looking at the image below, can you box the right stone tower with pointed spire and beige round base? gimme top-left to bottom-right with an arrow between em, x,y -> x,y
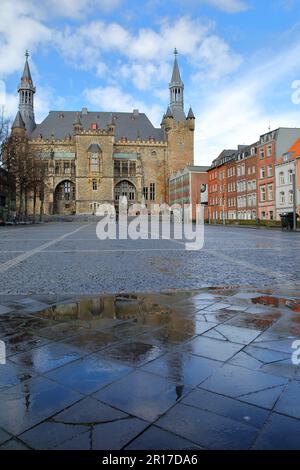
161,49 -> 195,190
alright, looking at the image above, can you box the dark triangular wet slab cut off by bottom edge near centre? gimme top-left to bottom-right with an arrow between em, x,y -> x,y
125,426 -> 201,450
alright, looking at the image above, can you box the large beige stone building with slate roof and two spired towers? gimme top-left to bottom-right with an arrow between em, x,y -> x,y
12,50 -> 195,214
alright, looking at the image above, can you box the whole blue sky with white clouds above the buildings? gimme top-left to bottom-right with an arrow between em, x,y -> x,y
0,0 -> 300,165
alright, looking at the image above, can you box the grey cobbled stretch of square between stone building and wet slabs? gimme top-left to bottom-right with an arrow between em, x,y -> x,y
0,222 -> 300,294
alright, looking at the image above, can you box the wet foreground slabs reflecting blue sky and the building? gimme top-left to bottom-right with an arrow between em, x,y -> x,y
0,287 -> 300,450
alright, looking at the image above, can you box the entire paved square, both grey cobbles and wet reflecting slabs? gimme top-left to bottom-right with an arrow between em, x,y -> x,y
0,223 -> 300,450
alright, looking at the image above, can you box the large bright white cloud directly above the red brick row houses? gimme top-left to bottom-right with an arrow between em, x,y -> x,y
194,38 -> 300,164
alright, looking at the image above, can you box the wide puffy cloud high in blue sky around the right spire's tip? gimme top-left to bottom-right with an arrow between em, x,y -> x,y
54,16 -> 242,84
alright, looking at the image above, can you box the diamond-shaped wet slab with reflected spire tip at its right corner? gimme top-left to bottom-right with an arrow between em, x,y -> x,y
94,370 -> 189,422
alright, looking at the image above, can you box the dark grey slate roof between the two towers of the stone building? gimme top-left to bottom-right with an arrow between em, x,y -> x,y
31,111 -> 165,142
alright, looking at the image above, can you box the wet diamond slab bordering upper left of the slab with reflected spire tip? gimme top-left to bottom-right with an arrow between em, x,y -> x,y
46,354 -> 132,394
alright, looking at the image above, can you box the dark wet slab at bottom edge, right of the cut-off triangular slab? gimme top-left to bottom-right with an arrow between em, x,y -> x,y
156,403 -> 258,450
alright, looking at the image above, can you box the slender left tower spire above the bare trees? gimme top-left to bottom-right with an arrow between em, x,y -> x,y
18,51 -> 36,136
